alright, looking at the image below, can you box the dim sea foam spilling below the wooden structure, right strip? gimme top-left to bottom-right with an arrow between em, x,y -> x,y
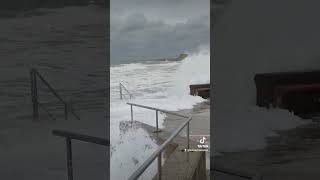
211,106 -> 310,152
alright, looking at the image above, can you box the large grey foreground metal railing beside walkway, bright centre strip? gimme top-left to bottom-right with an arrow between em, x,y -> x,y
127,103 -> 192,180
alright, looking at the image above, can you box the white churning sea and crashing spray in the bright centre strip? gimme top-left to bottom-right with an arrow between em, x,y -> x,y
110,51 -> 210,179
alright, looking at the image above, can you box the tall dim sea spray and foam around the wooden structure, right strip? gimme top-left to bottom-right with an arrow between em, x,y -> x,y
211,7 -> 319,151
